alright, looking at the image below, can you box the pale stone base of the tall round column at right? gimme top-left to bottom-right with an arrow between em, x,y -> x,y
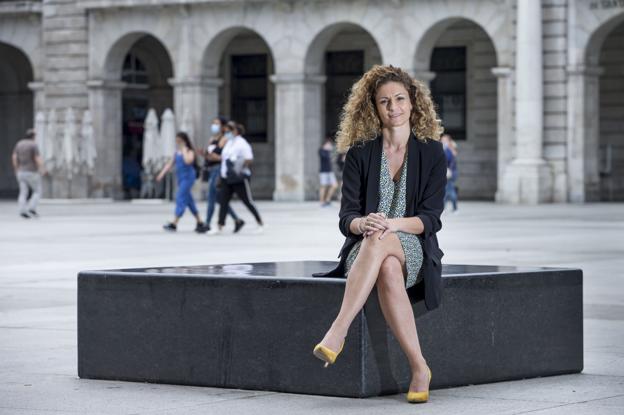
496,159 -> 553,205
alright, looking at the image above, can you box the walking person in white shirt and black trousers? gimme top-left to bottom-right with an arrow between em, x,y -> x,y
219,121 -> 264,232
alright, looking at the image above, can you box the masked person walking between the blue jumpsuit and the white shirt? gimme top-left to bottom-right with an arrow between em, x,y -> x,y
200,117 -> 245,234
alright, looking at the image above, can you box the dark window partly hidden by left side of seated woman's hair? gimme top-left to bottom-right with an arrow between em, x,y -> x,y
325,50 -> 364,135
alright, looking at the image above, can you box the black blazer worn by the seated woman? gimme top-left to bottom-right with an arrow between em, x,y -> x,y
316,134 -> 446,310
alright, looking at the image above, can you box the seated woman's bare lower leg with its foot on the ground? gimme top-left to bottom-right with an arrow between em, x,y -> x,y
377,256 -> 429,391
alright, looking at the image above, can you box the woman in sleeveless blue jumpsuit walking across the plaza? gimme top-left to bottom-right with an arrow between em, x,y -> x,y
156,132 -> 204,232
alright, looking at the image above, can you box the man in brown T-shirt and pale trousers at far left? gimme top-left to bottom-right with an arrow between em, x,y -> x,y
11,129 -> 43,219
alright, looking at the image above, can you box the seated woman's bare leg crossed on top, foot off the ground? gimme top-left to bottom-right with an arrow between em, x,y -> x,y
321,232 -> 405,351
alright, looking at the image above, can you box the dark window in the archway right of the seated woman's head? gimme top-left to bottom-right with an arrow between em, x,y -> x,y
431,47 -> 466,140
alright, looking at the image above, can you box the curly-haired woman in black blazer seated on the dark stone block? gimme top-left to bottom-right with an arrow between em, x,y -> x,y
313,66 -> 446,402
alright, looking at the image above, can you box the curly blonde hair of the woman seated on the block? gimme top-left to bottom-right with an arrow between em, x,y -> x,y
336,65 -> 443,153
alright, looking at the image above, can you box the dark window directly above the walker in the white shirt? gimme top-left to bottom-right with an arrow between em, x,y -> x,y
230,54 -> 269,143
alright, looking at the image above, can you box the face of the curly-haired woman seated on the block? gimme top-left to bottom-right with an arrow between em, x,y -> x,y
375,82 -> 412,128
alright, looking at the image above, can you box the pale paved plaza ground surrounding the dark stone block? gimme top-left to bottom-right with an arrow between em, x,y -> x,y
0,201 -> 624,415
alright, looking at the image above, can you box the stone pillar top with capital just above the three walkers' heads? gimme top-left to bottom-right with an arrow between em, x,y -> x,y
169,77 -> 223,148
